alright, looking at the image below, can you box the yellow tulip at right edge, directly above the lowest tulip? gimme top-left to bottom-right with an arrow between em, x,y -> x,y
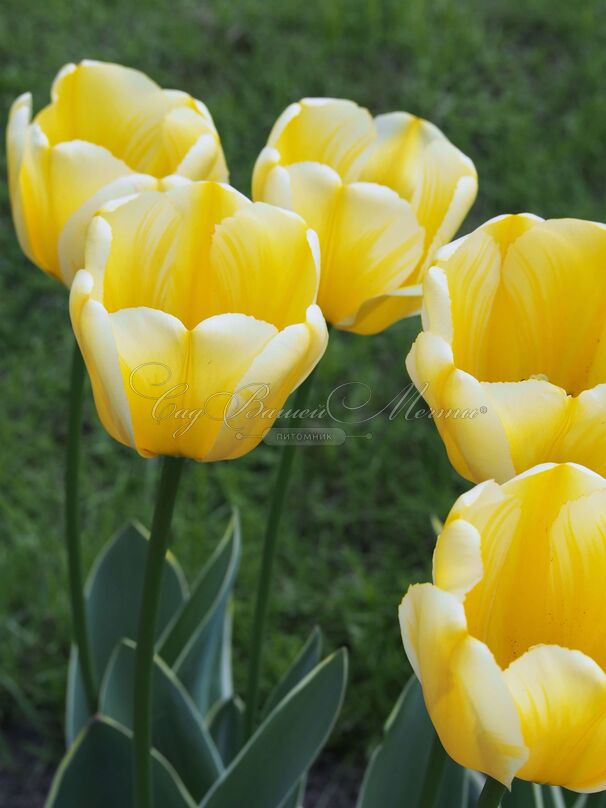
406,214 -> 606,482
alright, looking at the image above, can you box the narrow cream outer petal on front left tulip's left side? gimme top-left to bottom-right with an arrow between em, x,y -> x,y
69,270 -> 135,447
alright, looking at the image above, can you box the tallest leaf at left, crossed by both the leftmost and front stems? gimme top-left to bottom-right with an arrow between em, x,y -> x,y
66,523 -> 187,744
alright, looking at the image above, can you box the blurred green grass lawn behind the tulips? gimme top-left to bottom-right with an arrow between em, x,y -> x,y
0,0 -> 606,804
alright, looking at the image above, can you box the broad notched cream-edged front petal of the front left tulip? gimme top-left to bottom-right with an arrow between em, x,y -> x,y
111,308 -> 276,460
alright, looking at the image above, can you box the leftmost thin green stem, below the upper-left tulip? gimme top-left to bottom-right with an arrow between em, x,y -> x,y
65,341 -> 97,714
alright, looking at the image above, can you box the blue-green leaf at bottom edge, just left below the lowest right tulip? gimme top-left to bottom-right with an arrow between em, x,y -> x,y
357,676 -> 470,808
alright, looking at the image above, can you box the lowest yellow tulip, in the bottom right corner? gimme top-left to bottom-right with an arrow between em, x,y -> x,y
399,463 -> 606,792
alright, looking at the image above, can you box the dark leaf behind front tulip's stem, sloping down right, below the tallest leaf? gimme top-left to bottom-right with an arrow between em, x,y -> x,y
99,640 -> 223,800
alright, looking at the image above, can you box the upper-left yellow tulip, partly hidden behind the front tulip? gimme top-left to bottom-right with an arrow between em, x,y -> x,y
6,61 -> 227,287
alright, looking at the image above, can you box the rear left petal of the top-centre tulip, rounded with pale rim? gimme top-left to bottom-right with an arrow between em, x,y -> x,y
267,98 -> 375,180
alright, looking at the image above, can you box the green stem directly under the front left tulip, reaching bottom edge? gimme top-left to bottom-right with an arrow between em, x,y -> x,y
133,457 -> 183,808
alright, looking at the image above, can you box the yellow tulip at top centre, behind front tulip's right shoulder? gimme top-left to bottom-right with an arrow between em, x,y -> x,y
253,98 -> 477,334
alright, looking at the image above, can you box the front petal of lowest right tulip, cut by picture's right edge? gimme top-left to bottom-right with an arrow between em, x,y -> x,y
505,645 -> 606,791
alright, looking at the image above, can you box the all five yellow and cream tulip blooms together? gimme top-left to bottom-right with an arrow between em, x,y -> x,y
7,61 -> 606,791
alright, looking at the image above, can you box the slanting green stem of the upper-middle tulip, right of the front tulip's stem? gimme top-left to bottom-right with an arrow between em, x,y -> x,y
246,372 -> 314,737
